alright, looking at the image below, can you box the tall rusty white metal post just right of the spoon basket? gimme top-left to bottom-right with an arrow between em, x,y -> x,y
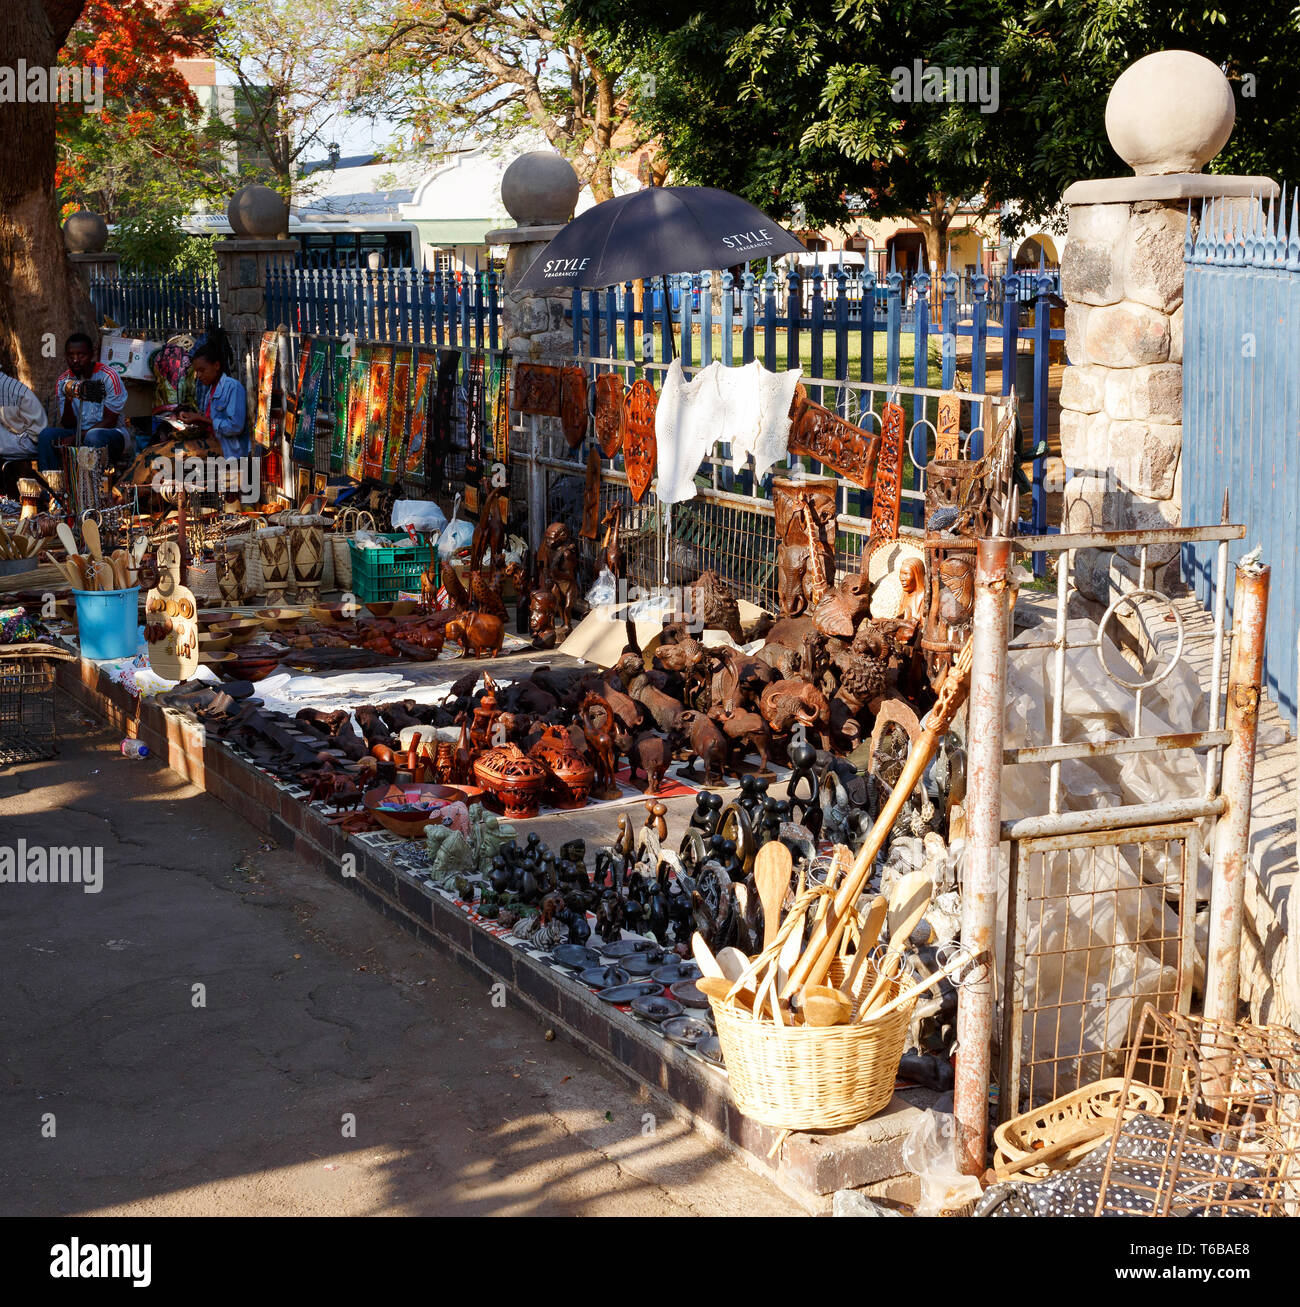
952,540 -> 1011,1175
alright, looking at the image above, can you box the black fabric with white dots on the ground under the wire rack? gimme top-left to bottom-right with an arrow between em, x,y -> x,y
975,1114 -> 1263,1217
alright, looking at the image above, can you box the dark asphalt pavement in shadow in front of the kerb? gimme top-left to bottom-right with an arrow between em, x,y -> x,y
0,701 -> 798,1216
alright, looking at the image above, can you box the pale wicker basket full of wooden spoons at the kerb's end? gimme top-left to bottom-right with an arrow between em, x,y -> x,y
709,959 -> 916,1131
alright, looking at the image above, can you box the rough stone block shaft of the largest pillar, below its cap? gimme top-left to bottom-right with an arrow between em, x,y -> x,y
1061,200 -> 1197,603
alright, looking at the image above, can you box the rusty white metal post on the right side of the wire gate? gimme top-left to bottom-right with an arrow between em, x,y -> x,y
1205,563 -> 1269,1021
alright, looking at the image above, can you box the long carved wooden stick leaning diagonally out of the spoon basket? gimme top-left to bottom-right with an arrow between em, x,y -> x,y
781,640 -> 972,999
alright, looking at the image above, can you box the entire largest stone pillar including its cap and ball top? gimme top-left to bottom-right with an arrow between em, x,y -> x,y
1061,50 -> 1278,604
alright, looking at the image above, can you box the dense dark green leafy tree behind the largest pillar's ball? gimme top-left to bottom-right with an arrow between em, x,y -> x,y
566,0 -> 1300,267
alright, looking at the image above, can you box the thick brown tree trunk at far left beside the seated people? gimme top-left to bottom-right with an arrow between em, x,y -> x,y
0,0 -> 94,404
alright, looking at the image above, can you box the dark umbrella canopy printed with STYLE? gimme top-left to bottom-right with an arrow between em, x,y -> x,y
511,186 -> 804,290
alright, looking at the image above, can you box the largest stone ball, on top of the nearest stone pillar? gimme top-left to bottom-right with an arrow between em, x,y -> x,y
1105,50 -> 1237,176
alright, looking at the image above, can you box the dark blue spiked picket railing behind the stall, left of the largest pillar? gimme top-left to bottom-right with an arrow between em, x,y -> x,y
88,254 -> 1065,533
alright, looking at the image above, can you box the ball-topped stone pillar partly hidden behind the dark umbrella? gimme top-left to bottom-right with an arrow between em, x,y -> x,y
486,150 -> 581,361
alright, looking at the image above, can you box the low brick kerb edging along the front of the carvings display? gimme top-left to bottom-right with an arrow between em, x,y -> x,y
57,660 -> 915,1212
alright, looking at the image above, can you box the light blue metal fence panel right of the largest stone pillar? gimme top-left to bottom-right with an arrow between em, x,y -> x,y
1182,192 -> 1300,728
